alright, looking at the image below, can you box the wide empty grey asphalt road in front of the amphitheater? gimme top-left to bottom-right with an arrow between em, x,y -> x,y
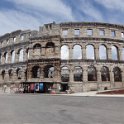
0,94 -> 124,124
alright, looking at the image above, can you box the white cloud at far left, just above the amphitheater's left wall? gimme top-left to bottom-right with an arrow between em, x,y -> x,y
0,10 -> 40,35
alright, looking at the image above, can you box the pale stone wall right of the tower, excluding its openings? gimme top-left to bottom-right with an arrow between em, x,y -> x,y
61,23 -> 124,92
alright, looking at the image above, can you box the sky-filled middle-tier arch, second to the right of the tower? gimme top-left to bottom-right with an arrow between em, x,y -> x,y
73,45 -> 82,59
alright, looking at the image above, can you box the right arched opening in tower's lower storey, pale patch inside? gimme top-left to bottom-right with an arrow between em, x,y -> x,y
44,65 -> 55,78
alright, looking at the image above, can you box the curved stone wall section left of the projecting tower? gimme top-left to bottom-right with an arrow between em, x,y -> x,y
0,30 -> 32,86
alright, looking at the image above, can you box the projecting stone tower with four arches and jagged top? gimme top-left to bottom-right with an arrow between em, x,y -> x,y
27,24 -> 61,93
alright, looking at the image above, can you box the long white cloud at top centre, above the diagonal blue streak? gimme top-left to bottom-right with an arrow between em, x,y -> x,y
8,0 -> 74,20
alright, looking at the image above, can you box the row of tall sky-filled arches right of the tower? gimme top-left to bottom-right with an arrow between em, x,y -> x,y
61,44 -> 124,61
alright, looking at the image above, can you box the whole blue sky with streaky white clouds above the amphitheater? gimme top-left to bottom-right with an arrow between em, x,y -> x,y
0,0 -> 124,35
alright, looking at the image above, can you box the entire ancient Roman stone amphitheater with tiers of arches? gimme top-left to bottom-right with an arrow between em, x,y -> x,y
0,22 -> 124,93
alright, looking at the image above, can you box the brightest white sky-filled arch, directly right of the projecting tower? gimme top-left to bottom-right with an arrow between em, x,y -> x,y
61,45 -> 69,60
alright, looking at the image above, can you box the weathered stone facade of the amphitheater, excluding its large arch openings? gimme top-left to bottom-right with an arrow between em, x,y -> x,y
0,22 -> 124,92
